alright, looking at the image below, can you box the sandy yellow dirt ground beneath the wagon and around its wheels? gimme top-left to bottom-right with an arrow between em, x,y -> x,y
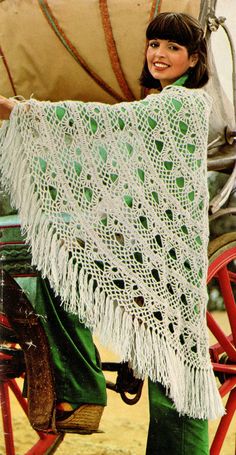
0,312 -> 236,455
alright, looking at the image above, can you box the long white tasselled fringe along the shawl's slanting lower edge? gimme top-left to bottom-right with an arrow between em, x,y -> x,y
1,103 -> 224,419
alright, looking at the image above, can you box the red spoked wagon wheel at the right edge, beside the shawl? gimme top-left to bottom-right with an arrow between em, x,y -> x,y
207,232 -> 236,455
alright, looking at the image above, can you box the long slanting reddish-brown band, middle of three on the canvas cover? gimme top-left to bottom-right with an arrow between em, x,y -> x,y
38,0 -> 125,101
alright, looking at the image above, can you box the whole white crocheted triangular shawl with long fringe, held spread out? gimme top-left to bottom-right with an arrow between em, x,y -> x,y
1,86 -> 223,418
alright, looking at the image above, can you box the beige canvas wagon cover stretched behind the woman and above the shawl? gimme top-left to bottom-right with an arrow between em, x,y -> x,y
0,0 -> 200,102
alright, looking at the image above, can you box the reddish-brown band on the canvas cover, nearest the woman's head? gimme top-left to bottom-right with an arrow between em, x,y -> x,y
99,0 -> 135,101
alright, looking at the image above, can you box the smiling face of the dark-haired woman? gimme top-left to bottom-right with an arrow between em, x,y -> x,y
147,39 -> 198,88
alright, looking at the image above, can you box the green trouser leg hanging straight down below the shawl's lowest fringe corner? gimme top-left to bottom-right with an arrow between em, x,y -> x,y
146,381 -> 209,455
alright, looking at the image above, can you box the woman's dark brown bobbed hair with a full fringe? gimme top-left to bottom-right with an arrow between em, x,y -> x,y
139,13 -> 209,89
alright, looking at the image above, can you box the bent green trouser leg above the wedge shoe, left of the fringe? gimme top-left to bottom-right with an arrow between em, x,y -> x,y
17,278 -> 106,405
